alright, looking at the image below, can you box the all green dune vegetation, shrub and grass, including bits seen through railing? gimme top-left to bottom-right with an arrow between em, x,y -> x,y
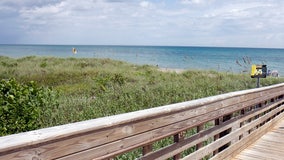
0,56 -> 284,160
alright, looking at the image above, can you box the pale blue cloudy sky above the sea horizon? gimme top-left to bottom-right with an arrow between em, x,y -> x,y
0,0 -> 284,48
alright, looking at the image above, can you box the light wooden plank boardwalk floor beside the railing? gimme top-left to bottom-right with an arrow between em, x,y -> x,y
234,119 -> 284,160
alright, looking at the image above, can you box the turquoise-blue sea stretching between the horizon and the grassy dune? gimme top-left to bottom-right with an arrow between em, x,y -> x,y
0,45 -> 284,76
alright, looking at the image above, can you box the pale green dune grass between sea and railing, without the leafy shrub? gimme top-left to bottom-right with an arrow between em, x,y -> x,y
0,56 -> 284,127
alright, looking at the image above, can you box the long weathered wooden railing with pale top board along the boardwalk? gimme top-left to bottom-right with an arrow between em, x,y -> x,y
0,84 -> 284,160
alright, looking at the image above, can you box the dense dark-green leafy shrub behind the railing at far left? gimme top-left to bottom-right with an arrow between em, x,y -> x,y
0,79 -> 57,136
